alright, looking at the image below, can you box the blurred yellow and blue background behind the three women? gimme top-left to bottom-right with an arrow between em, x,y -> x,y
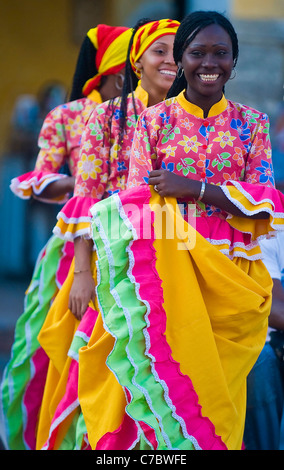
0,0 -> 284,368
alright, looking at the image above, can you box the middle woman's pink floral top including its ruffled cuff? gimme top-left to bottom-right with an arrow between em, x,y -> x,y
54,85 -> 148,240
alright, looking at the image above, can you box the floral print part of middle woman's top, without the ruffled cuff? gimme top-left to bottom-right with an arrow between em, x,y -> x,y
74,86 -> 148,199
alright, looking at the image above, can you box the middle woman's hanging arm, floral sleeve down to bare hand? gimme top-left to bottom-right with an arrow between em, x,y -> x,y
64,103 -> 110,320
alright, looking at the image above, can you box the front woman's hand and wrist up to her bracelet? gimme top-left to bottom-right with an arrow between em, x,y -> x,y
149,169 -> 201,199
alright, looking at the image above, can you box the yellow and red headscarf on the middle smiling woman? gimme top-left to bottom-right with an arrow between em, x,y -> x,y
130,19 -> 180,78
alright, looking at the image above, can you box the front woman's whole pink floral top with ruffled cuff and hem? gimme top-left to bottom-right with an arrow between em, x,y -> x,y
128,92 -> 284,257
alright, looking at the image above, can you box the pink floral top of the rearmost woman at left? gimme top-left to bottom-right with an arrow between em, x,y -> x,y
11,96 -> 101,203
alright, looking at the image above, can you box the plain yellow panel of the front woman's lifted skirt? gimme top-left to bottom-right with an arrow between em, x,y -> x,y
151,192 -> 272,450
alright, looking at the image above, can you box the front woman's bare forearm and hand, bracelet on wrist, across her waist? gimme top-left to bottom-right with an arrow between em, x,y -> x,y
149,169 -> 269,219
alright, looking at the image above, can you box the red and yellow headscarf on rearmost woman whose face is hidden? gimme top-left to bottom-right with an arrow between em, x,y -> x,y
83,24 -> 132,96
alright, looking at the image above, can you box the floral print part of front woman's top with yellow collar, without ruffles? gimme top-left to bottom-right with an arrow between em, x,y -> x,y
128,93 -> 274,220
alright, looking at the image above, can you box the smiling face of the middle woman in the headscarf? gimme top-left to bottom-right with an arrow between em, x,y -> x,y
136,34 -> 177,97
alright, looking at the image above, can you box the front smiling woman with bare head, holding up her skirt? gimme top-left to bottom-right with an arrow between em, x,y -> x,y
79,11 -> 284,450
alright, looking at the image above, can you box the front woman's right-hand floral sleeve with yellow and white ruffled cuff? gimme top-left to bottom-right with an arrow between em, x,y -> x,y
221,114 -> 284,239
